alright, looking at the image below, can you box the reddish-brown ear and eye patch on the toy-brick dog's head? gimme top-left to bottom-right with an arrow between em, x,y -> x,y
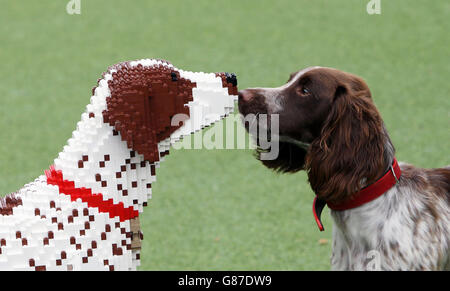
103,63 -> 196,163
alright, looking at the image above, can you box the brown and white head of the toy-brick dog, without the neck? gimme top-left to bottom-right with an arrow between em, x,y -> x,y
93,59 -> 237,163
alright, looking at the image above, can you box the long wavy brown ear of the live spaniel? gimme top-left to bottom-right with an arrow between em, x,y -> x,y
306,84 -> 384,202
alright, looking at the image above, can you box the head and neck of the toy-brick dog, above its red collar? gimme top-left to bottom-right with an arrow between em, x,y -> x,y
54,59 -> 237,221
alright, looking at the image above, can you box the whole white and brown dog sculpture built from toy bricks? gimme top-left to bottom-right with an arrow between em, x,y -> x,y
0,59 -> 237,271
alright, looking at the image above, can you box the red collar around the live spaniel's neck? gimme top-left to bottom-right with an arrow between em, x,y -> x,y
313,158 -> 402,231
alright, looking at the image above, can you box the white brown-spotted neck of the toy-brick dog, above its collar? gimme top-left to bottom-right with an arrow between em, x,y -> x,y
54,74 -> 160,216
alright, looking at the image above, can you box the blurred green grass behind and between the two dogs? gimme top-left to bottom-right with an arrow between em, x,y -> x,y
0,0 -> 450,270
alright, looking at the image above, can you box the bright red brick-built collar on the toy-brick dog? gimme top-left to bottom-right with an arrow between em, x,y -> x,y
45,166 -> 139,222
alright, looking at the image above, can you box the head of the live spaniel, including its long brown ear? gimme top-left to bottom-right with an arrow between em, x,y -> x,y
239,67 -> 384,201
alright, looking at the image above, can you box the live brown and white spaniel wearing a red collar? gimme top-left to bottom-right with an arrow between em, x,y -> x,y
238,67 -> 450,270
